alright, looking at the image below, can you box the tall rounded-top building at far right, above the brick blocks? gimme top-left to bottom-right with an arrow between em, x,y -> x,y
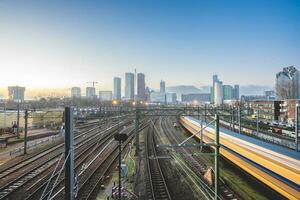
275,66 -> 300,100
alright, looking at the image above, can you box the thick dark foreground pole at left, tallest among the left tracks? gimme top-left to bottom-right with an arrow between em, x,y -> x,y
65,107 -> 75,200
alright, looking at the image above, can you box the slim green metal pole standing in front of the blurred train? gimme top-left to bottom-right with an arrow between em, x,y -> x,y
215,114 -> 220,200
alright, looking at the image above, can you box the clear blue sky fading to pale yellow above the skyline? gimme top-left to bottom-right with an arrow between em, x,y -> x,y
0,0 -> 300,89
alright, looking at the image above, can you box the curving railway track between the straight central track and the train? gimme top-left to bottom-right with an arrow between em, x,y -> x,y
161,118 -> 239,200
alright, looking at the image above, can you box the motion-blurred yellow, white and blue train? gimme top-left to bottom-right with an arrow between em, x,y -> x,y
180,117 -> 300,199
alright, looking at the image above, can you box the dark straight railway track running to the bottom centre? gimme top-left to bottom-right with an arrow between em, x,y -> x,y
145,119 -> 171,200
